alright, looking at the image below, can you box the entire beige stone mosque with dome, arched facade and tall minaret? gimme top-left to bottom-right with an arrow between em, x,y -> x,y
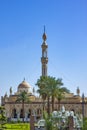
1,30 -> 87,121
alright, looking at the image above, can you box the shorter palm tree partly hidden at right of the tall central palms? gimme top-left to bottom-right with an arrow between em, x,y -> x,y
56,87 -> 70,110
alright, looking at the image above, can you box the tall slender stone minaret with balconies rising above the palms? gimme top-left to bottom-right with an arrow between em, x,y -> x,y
41,27 -> 48,76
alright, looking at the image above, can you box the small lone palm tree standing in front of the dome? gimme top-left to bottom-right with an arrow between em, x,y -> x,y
16,91 -> 30,122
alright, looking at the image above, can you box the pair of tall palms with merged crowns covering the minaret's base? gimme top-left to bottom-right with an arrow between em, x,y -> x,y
36,76 -> 63,113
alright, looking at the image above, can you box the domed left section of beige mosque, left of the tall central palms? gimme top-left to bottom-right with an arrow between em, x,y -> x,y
1,80 -> 42,121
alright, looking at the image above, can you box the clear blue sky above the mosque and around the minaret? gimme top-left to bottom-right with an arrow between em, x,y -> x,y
0,0 -> 87,96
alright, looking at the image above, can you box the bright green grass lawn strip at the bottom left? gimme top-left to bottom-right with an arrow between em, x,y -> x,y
0,123 -> 30,130
